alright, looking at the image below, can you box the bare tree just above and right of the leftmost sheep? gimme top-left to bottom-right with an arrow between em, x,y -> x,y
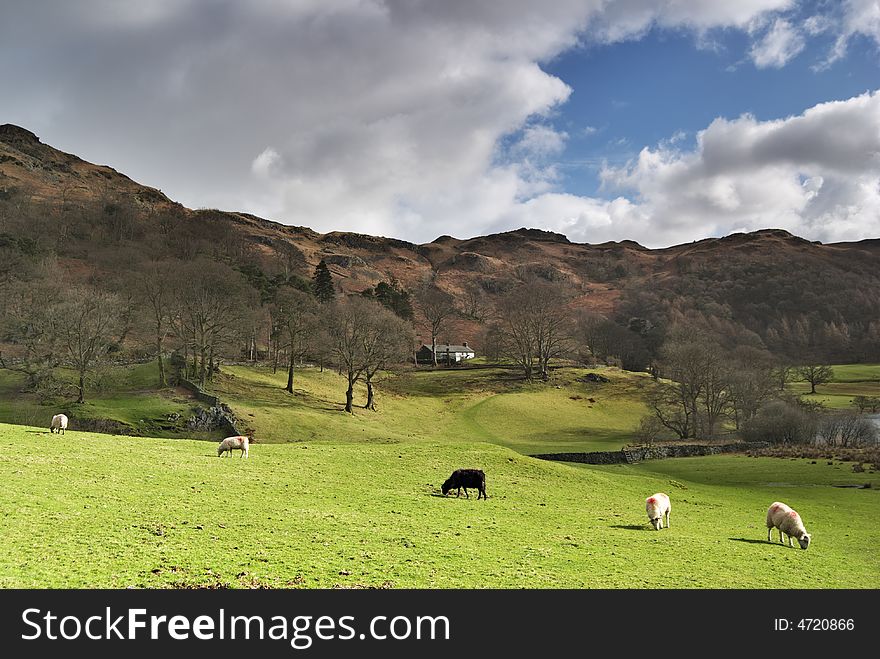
59,287 -> 120,403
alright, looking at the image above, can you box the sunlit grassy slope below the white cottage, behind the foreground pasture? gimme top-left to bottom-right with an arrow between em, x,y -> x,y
212,366 -> 646,453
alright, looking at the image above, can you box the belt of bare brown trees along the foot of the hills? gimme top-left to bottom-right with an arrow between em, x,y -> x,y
0,201 -> 867,430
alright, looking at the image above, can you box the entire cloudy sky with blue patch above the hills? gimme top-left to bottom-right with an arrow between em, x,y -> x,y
0,0 -> 880,247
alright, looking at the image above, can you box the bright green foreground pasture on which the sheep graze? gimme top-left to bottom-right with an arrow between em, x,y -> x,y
0,425 -> 880,588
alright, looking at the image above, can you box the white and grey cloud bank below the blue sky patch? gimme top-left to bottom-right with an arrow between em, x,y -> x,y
602,92 -> 880,245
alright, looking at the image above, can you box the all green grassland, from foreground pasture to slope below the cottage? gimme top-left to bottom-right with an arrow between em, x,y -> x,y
0,365 -> 880,588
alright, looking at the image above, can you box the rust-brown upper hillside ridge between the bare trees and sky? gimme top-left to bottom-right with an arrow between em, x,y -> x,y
0,124 -> 880,361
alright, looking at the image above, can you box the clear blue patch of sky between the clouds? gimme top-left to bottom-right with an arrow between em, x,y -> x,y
543,21 -> 880,200
